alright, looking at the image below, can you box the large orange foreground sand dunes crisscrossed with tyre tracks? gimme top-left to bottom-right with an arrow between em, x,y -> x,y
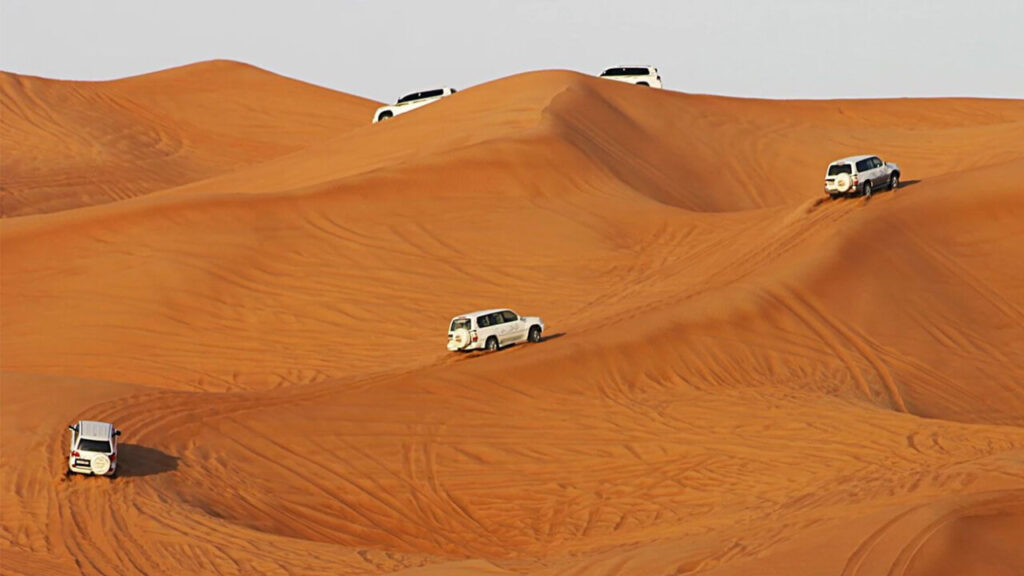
0,69 -> 1024,576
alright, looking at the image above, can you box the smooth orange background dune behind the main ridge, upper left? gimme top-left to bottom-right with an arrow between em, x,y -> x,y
0,60 -> 377,217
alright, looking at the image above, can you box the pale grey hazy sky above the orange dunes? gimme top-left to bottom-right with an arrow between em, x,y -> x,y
0,0 -> 1024,101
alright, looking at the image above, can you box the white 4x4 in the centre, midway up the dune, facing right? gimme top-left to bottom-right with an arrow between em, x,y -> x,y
449,308 -> 544,352
